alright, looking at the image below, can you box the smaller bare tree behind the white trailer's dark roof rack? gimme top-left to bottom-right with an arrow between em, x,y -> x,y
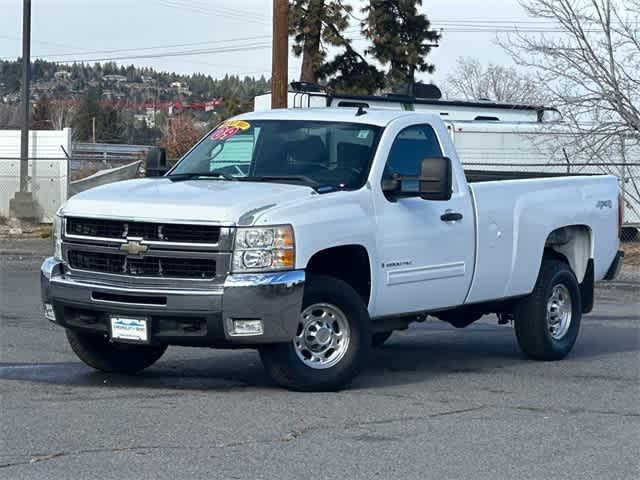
443,58 -> 545,104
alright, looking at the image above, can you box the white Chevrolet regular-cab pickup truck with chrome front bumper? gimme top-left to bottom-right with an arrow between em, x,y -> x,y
41,108 -> 622,390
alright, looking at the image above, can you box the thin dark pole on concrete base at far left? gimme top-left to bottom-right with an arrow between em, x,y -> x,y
9,0 -> 38,219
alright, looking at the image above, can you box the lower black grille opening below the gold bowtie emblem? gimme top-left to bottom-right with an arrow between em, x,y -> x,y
67,250 -> 216,279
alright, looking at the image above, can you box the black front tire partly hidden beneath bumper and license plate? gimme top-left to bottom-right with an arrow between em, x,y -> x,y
67,330 -> 167,374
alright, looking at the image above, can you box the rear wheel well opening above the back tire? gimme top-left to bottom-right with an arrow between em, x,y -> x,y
544,225 -> 592,283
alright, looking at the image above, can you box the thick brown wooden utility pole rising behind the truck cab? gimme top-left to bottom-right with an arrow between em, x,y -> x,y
271,0 -> 289,108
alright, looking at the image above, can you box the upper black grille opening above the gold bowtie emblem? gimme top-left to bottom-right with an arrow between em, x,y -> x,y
66,217 -> 220,244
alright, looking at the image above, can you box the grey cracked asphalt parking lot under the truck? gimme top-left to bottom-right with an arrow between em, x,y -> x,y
0,239 -> 640,480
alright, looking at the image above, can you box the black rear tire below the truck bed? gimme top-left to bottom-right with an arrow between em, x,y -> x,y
514,260 -> 582,360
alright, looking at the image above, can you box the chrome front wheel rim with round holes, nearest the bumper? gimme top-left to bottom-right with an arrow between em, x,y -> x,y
293,303 -> 351,370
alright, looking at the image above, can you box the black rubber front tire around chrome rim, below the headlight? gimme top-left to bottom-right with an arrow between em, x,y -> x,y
260,275 -> 371,391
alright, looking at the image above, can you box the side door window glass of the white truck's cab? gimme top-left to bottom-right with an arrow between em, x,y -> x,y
384,125 -> 442,176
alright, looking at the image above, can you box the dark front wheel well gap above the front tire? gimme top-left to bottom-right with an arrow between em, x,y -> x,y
306,245 -> 371,305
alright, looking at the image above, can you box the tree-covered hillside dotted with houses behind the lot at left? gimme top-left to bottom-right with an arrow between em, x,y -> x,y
0,60 -> 269,145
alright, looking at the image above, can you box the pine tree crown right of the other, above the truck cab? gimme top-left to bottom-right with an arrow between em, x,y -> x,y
362,0 -> 440,94
